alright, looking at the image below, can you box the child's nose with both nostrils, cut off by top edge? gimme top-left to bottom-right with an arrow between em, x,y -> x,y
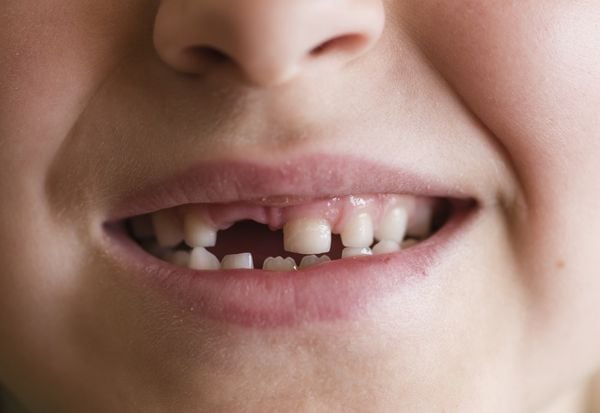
154,0 -> 385,87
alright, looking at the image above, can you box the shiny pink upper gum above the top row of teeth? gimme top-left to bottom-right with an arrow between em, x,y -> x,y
179,195 -> 435,234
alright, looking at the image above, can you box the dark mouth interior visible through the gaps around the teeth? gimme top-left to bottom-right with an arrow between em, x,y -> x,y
125,199 -> 458,265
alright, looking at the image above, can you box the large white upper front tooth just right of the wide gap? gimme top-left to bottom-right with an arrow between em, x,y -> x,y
283,218 -> 331,254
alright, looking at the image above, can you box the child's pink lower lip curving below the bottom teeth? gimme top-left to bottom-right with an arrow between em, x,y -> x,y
106,208 -> 477,328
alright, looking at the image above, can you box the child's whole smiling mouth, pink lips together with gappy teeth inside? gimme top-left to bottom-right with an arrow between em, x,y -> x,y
103,157 -> 480,327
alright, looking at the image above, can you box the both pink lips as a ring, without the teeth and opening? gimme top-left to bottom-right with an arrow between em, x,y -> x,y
103,155 -> 478,328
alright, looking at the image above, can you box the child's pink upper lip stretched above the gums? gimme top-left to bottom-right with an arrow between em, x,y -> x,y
110,154 -> 477,220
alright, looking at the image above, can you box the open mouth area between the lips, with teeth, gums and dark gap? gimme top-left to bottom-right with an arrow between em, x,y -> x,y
125,194 -> 460,272
